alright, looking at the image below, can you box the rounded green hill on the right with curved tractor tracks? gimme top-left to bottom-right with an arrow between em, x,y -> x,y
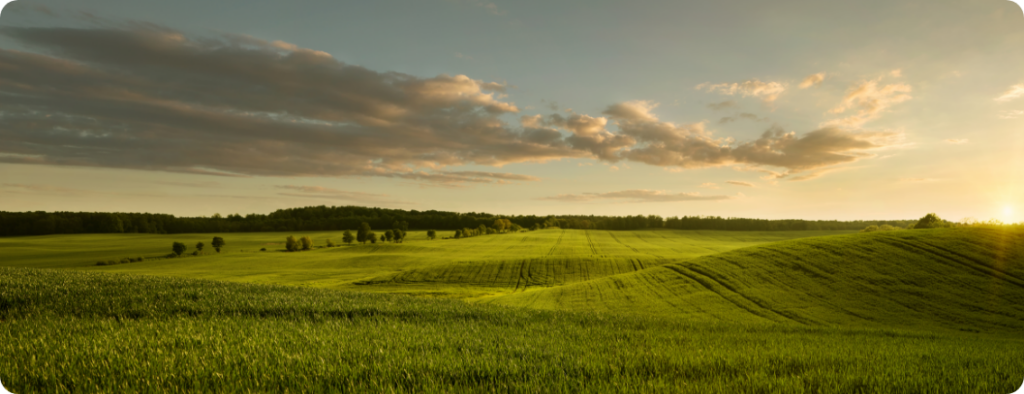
489,228 -> 1024,335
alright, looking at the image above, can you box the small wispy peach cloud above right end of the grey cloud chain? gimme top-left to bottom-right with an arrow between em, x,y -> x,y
822,78 -> 911,127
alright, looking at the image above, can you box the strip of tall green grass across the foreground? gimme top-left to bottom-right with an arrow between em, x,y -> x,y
0,267 -> 1024,394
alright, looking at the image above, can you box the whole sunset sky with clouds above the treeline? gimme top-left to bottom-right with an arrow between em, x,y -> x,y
0,0 -> 1024,222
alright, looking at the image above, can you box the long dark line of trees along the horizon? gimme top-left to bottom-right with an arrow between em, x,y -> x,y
0,206 -> 916,236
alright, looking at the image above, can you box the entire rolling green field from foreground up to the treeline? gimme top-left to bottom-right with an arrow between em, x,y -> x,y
0,228 -> 1024,393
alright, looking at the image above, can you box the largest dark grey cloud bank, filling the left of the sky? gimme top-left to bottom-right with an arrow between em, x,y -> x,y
0,27 -> 577,181
